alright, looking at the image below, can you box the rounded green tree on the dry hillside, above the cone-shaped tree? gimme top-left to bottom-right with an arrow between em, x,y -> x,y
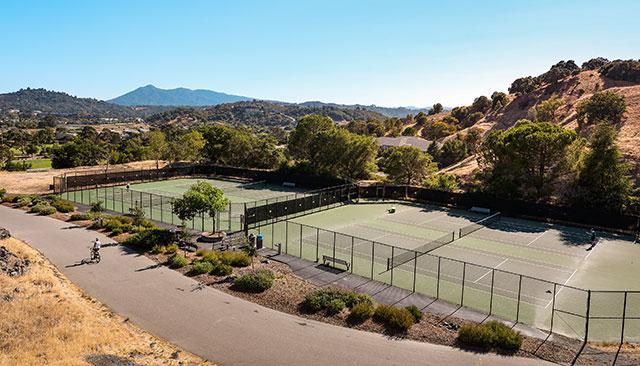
576,91 -> 627,127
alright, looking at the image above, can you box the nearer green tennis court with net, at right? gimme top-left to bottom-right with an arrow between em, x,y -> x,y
250,203 -> 640,341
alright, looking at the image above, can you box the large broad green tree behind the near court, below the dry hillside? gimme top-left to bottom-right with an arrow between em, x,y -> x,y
479,120 -> 576,200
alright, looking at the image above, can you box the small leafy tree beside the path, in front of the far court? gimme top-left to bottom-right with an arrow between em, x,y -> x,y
171,181 -> 229,230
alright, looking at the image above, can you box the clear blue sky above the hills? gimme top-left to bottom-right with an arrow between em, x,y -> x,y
0,0 -> 640,106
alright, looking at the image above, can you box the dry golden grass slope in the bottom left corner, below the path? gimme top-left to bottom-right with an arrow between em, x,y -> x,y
0,239 -> 211,366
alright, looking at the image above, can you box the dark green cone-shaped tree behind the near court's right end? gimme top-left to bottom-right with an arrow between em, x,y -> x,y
572,123 -> 632,212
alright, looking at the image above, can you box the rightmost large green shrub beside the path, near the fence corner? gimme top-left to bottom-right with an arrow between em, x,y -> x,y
458,320 -> 522,352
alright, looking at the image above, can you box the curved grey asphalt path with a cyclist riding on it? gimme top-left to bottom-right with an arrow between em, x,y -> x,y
0,206 -> 547,366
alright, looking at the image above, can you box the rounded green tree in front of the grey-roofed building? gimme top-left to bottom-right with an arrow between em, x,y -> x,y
379,146 -> 437,185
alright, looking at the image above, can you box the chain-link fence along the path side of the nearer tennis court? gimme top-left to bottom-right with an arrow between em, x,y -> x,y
250,221 -> 640,342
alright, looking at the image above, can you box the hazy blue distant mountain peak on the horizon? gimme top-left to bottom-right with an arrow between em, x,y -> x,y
108,84 -> 252,107
